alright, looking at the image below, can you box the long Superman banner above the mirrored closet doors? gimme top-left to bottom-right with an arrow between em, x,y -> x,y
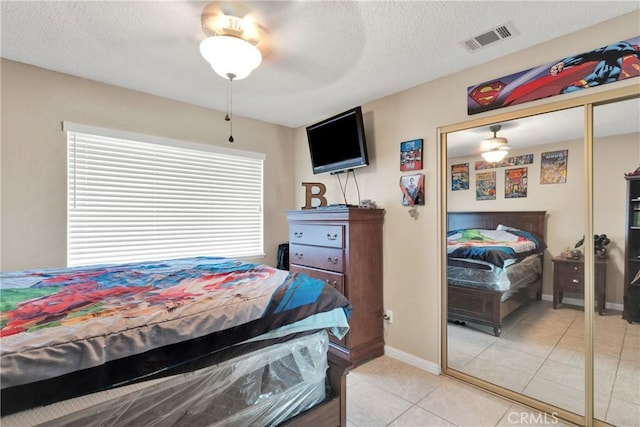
467,36 -> 640,115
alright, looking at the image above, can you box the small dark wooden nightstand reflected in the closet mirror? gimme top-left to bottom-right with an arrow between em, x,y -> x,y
552,257 -> 607,314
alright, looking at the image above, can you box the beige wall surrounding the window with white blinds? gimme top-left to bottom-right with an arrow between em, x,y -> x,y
0,59 -> 294,271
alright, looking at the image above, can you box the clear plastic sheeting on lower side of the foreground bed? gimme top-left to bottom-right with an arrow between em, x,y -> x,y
2,331 -> 328,427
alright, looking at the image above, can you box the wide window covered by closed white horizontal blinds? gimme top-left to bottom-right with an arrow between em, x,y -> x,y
63,122 -> 264,266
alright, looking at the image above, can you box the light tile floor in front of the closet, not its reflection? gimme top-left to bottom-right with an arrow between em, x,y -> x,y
347,356 -> 569,427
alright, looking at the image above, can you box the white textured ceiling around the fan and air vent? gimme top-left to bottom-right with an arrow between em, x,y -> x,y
1,0 -> 640,127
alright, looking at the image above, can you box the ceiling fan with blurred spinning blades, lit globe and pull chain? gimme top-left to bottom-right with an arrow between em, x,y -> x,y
192,0 -> 366,135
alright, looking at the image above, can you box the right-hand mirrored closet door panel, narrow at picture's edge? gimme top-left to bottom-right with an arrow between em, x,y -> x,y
593,98 -> 640,425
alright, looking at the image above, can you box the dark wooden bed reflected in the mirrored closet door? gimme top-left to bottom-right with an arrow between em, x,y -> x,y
447,211 -> 546,337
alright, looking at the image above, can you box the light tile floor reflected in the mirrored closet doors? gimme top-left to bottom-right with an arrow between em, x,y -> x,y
448,301 -> 640,427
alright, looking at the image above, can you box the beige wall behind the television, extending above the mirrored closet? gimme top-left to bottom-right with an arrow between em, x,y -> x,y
295,13 -> 640,363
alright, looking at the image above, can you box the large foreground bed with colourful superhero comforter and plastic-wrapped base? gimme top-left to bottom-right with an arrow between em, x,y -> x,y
0,257 -> 350,426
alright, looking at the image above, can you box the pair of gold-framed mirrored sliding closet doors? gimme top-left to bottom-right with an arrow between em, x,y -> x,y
441,87 -> 640,425
